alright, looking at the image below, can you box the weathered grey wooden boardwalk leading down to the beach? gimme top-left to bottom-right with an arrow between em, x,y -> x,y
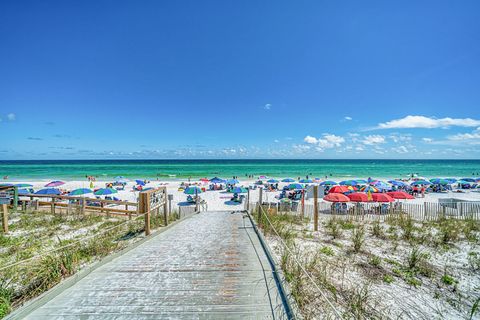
20,212 -> 286,319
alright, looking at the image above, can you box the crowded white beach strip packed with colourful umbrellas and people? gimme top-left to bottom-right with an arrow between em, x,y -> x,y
0,175 -> 480,210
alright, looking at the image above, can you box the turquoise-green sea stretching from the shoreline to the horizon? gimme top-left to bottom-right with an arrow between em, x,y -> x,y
0,160 -> 480,180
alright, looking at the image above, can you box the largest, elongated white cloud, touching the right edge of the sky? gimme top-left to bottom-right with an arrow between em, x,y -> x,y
374,116 -> 480,129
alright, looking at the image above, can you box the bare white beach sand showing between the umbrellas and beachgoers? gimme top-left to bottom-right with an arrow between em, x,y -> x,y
10,178 -> 480,210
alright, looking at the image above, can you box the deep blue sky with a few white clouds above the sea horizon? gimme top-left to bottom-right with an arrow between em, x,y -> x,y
0,0 -> 480,159
